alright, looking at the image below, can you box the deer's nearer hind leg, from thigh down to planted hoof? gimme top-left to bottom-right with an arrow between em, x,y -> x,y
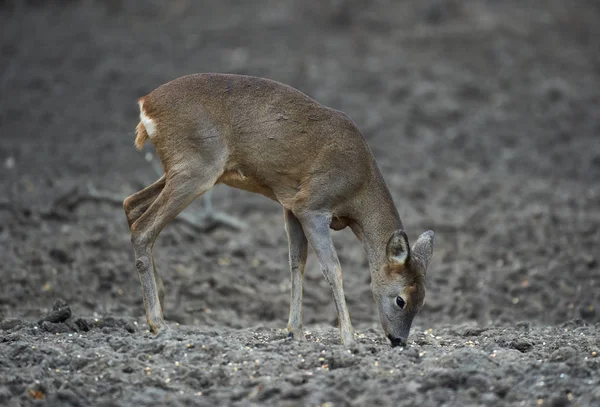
131,168 -> 222,333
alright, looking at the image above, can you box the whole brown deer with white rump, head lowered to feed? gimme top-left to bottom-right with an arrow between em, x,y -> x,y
123,73 -> 434,347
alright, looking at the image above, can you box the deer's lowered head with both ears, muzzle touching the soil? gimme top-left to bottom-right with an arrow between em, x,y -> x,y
371,230 -> 433,346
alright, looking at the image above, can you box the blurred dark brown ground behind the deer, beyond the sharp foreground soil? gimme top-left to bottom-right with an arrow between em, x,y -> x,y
0,0 -> 600,329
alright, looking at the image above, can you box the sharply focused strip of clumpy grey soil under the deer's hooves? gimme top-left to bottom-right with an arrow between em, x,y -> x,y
0,310 -> 600,406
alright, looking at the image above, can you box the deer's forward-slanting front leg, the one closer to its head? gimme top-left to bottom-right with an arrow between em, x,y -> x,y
299,213 -> 354,346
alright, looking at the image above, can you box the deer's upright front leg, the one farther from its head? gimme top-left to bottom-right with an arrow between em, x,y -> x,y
283,209 -> 308,340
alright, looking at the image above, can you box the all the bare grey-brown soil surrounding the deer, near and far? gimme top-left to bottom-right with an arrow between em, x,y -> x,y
0,0 -> 600,406
